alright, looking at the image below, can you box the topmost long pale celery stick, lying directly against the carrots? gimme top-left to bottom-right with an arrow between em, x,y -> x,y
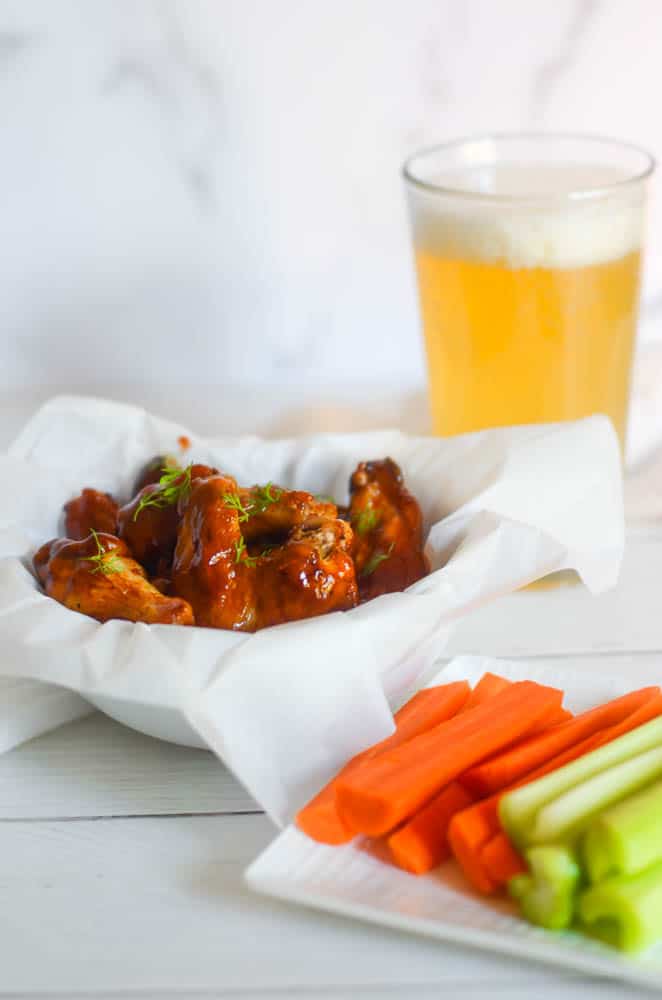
499,717 -> 662,848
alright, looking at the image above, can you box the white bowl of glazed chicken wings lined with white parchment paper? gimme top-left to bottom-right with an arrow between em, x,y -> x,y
0,397 -> 622,768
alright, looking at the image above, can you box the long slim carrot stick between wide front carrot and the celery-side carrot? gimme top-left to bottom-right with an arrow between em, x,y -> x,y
462,687 -> 660,795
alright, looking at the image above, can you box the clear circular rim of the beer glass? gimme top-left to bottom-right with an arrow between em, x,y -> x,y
402,132 -> 657,205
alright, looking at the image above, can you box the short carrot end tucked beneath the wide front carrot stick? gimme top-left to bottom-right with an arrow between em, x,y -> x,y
386,781 -> 473,875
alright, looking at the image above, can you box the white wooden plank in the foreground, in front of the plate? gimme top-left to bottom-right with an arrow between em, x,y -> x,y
0,816 -> 640,1000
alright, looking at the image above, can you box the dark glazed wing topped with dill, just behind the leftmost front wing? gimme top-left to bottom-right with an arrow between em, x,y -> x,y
117,465 -> 216,578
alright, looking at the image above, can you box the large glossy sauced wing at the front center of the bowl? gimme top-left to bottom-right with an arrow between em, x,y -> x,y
172,475 -> 358,632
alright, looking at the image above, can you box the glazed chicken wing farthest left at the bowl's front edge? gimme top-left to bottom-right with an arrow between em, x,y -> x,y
33,531 -> 194,625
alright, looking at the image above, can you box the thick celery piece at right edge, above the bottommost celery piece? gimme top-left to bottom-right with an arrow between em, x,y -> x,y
582,781 -> 662,882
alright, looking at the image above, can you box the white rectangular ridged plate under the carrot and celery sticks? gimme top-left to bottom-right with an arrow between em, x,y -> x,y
245,657 -> 662,991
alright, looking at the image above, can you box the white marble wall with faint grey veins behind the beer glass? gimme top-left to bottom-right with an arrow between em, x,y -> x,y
0,0 -> 662,458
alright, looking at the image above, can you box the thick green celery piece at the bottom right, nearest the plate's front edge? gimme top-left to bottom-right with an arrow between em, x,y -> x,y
578,862 -> 662,951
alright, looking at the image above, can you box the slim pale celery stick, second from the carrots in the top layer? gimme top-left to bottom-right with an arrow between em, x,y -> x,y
527,746 -> 662,844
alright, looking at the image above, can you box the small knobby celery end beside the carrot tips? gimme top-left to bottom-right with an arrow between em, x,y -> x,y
508,844 -> 581,931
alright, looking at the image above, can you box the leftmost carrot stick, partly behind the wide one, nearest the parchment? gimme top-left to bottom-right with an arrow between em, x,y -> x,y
296,681 -> 470,844
